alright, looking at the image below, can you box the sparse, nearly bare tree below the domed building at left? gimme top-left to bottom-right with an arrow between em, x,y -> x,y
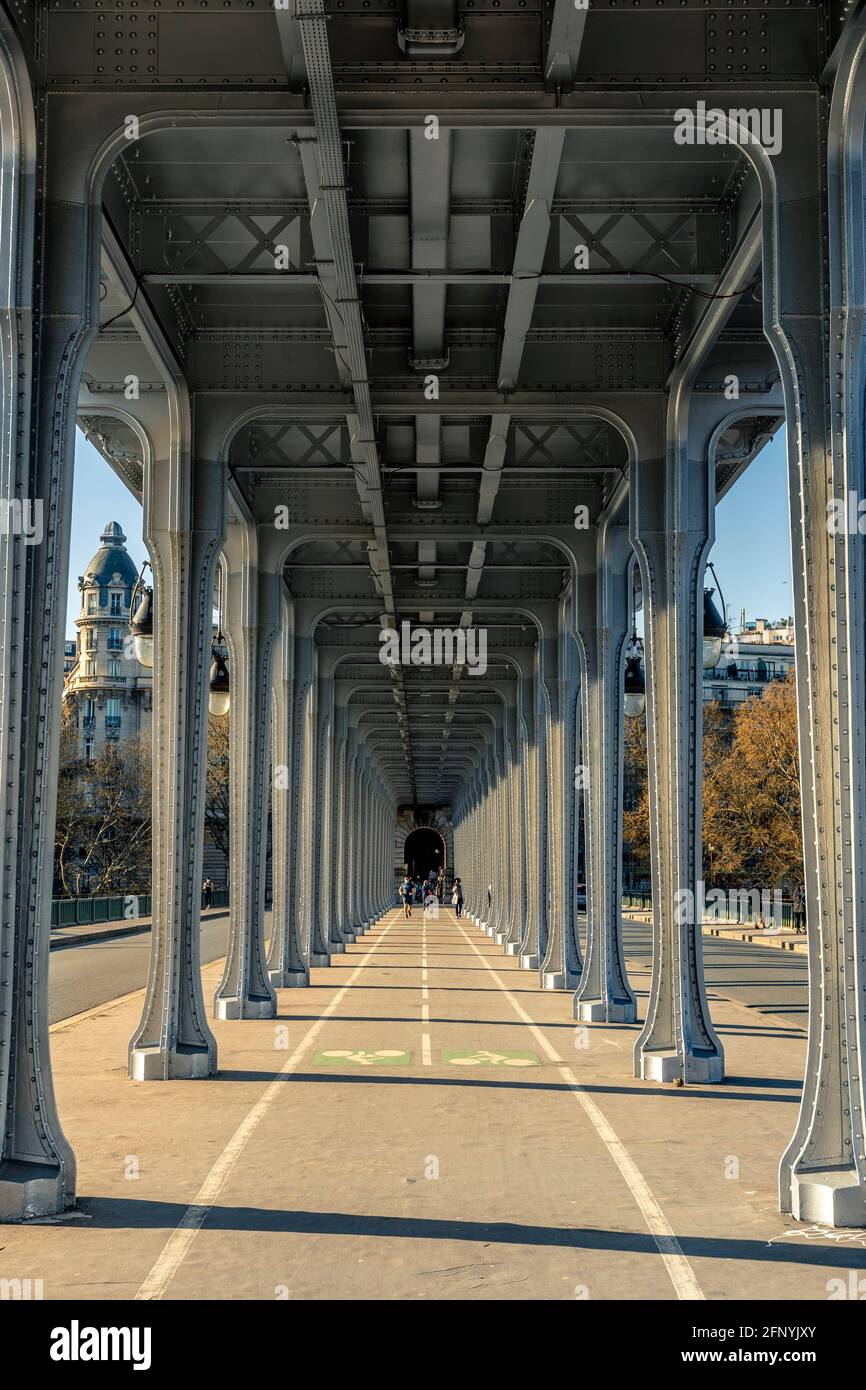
54,720 -> 152,898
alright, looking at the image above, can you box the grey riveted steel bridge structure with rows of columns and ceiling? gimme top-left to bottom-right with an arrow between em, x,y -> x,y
0,0 -> 866,1226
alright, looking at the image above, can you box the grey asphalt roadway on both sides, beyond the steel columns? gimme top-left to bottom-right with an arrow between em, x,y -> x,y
49,915 -> 808,1033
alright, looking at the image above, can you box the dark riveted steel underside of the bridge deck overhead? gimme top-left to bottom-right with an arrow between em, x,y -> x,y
74,0 -> 819,805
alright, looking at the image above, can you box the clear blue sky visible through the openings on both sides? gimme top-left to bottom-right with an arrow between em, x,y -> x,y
67,431 -> 791,637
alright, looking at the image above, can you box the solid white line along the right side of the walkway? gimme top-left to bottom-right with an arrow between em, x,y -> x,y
460,927 -> 705,1300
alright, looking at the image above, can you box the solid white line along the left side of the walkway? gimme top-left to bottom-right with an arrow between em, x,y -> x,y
135,919 -> 395,1300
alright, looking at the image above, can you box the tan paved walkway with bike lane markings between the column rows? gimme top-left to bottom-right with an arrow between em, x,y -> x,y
0,910 -> 866,1300
